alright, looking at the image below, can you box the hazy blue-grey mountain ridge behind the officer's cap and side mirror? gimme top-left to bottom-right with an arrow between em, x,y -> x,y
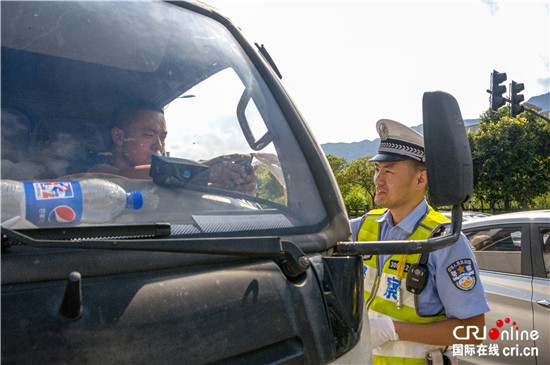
321,93 -> 550,161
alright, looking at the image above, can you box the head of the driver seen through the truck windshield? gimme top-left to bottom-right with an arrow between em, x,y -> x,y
122,110 -> 167,166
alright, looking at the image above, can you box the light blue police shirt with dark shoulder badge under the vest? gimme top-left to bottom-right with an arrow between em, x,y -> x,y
350,199 -> 490,319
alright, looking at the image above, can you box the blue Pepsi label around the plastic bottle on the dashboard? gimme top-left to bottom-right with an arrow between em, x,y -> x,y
24,182 -> 82,223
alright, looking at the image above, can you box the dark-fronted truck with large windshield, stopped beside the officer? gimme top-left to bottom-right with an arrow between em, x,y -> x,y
0,0 -> 472,364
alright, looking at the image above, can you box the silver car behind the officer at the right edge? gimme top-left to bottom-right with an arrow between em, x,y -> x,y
461,210 -> 550,364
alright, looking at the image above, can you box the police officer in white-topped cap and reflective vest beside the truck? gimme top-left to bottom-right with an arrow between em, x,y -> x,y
350,119 -> 490,364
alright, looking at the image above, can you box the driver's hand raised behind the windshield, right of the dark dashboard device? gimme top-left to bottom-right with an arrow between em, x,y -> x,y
202,153 -> 256,194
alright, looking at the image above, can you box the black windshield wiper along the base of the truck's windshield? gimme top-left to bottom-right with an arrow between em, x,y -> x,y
2,223 -> 309,278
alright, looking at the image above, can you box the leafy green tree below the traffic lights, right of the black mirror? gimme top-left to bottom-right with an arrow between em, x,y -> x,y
468,108 -> 550,210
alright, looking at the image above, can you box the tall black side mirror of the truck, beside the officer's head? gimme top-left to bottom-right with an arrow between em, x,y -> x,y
422,91 -> 474,207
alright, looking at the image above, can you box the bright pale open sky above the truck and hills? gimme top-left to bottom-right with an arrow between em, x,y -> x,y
204,0 -> 550,143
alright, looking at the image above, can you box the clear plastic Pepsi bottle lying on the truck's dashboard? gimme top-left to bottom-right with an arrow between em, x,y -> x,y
1,179 -> 143,225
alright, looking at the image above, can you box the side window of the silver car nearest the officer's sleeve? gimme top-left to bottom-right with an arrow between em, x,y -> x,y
464,227 -> 521,274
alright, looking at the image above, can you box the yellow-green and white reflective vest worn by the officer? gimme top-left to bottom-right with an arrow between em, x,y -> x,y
358,207 -> 449,364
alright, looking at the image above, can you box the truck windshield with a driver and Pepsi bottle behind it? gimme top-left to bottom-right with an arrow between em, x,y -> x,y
1,1 -> 328,236
